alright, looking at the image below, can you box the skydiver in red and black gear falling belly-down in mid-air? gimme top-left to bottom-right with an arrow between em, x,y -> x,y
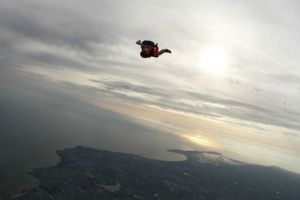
136,40 -> 171,58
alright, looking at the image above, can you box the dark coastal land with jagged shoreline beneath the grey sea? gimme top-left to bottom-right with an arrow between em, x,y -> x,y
11,146 -> 300,200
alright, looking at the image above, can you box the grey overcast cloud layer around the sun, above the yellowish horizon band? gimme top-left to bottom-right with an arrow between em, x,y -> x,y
0,0 -> 300,134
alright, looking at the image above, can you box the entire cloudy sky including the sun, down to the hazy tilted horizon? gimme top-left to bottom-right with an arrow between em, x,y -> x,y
0,0 -> 300,172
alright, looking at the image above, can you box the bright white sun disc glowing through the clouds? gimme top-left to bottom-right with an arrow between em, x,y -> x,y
199,47 -> 229,75
